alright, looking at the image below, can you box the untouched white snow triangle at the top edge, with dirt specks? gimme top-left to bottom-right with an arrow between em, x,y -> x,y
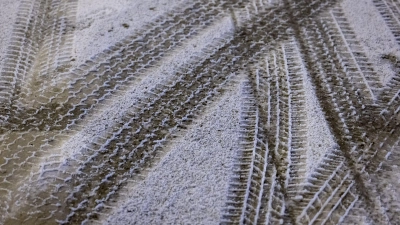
75,0 -> 191,65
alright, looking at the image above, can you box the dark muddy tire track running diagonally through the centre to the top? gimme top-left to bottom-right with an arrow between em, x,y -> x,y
3,1 -> 340,222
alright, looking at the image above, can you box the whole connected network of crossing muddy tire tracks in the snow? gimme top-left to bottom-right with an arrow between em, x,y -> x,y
0,0 -> 400,224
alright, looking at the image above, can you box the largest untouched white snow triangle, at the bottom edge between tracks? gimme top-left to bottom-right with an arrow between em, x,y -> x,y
104,80 -> 240,224
